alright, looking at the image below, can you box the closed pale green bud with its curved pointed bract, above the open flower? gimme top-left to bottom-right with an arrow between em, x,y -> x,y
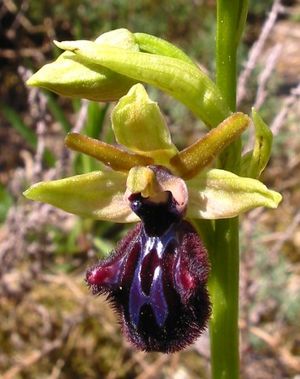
27,29 -> 230,127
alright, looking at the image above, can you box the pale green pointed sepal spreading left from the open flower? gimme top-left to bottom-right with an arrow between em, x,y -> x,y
24,171 -> 138,223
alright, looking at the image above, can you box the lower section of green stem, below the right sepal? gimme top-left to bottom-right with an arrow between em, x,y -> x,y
209,218 -> 239,379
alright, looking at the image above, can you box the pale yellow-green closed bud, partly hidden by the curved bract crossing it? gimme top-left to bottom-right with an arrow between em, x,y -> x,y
27,29 -> 138,102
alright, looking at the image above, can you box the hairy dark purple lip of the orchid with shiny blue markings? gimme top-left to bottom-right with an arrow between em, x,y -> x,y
86,187 -> 210,353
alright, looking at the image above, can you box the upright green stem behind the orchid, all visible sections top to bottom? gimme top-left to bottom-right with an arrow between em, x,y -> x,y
209,0 -> 247,379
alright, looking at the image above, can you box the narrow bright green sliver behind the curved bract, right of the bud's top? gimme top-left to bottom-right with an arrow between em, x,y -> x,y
134,33 -> 195,64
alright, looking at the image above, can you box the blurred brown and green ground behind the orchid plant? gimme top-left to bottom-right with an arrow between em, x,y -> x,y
0,0 -> 300,379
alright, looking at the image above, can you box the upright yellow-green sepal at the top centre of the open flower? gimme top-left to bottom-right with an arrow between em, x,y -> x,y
112,84 -> 177,164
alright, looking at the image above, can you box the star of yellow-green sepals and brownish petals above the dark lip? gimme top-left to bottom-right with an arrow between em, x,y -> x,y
24,84 -> 281,222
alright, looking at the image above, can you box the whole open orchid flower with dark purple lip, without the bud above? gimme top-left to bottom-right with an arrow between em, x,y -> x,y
25,84 -> 280,352
